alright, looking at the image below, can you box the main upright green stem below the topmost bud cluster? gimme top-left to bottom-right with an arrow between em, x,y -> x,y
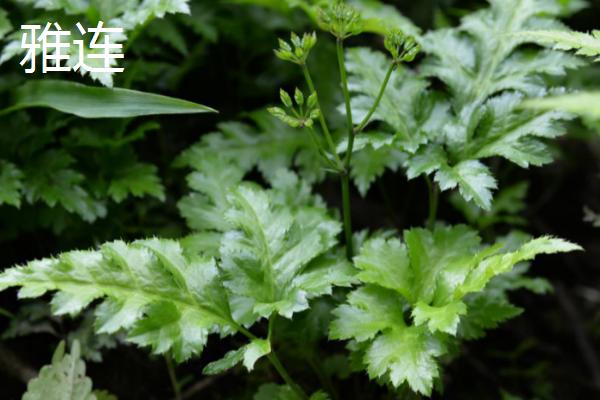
336,39 -> 354,260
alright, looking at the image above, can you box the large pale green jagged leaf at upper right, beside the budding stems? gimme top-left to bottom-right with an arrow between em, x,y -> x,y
349,0 -> 581,209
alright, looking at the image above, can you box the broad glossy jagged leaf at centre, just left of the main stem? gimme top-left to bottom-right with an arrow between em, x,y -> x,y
221,186 -> 351,324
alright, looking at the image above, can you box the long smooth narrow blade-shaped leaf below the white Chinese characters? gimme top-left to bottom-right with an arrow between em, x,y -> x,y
0,79 -> 215,118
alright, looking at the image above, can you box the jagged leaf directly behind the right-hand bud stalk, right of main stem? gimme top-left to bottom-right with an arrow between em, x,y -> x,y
338,48 -> 448,196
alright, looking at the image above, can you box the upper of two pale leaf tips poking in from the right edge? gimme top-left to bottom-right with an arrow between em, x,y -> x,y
518,30 -> 600,61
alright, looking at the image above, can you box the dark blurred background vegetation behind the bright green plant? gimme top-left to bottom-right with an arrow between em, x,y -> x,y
0,0 -> 600,399
